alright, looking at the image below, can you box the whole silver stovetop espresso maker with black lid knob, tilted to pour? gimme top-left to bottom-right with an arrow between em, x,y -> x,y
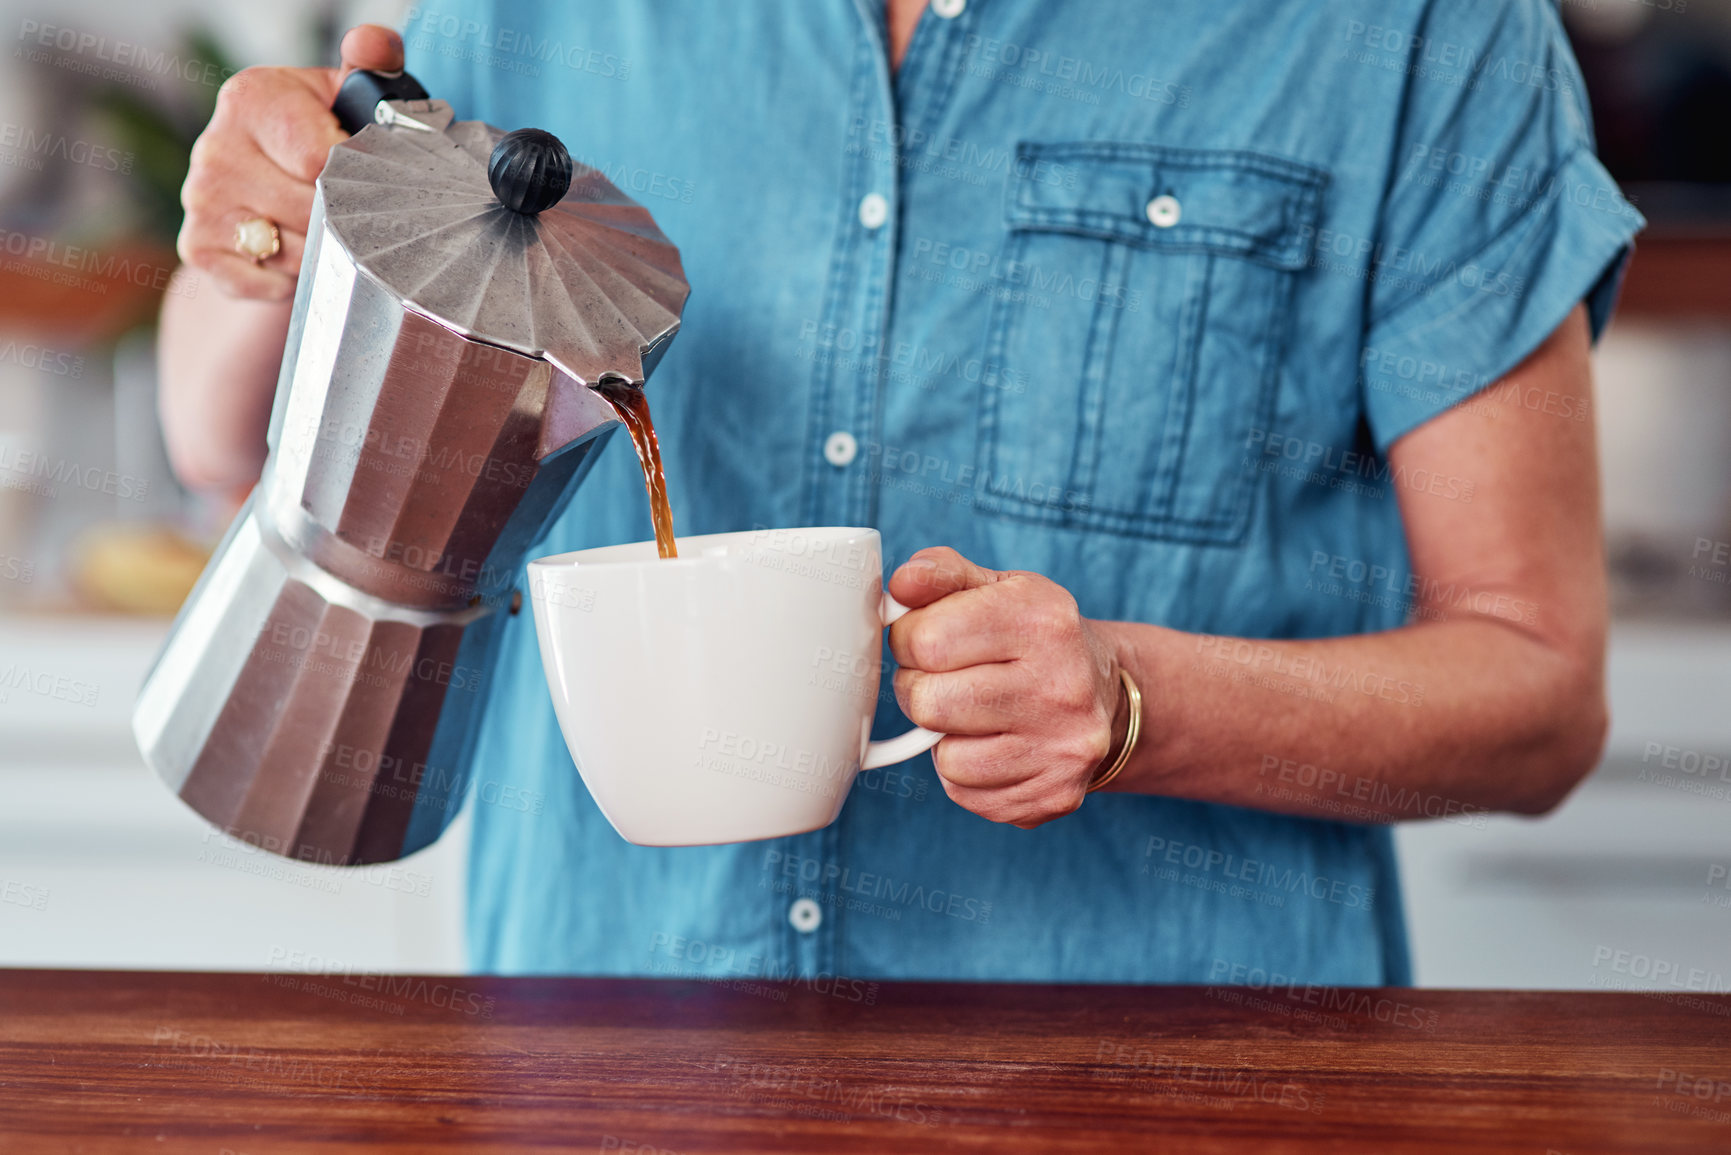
133,73 -> 689,864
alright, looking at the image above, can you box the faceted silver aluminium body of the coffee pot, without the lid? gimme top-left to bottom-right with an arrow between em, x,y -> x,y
133,197 -> 620,864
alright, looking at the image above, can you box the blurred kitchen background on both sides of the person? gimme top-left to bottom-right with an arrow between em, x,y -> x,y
0,0 -> 1731,990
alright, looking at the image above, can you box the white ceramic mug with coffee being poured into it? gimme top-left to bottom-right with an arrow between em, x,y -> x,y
528,528 -> 942,847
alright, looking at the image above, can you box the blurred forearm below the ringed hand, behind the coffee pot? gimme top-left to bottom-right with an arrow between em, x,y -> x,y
158,270 -> 293,490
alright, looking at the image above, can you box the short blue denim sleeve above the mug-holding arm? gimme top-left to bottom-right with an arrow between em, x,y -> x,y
1359,0 -> 1646,452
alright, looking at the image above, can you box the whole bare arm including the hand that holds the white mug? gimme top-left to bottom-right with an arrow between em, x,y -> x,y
890,308 -> 1606,826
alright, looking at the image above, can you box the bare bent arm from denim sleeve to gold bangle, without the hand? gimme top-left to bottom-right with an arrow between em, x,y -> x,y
1101,308 -> 1606,819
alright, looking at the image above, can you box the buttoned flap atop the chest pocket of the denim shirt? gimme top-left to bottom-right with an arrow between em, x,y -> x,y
1006,140 -> 1328,268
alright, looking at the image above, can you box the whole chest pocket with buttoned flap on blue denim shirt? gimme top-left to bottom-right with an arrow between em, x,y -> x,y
975,142 -> 1328,545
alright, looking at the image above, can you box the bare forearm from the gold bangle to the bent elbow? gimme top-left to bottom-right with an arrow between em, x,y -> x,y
1094,615 -> 1605,821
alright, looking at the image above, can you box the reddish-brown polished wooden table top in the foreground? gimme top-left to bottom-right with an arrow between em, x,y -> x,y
0,970 -> 1731,1155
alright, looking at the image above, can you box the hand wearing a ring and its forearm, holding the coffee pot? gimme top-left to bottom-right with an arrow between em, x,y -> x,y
158,26 -> 403,490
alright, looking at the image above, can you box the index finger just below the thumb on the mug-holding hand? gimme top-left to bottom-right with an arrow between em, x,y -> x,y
890,573 -> 1066,674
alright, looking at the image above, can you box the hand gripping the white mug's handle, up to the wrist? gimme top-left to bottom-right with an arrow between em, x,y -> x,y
890,547 -> 1120,828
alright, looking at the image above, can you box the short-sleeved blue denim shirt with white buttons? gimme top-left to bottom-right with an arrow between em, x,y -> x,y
407,0 -> 1641,984
